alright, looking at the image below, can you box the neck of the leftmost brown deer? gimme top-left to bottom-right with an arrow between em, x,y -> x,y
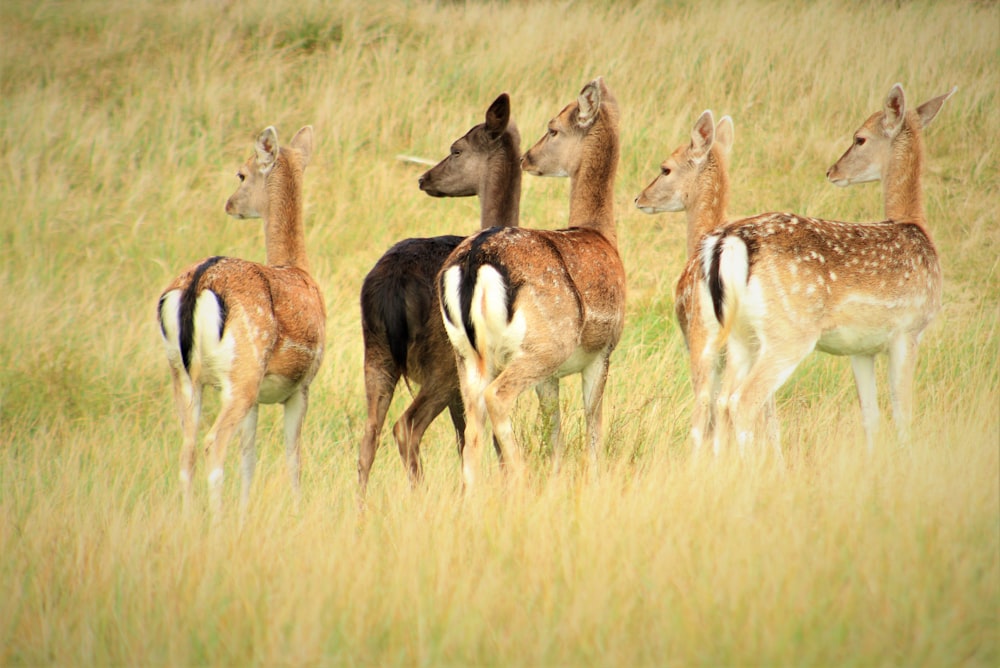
264,164 -> 309,272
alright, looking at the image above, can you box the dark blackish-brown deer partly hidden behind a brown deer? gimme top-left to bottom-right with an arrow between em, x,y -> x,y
358,93 -> 559,497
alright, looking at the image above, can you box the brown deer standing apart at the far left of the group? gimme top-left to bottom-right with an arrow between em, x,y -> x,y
157,125 -> 326,520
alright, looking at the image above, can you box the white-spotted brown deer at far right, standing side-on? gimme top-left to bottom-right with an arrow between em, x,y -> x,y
700,84 -> 955,454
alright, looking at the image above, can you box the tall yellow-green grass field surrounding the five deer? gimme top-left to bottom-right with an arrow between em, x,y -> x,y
0,0 -> 1000,666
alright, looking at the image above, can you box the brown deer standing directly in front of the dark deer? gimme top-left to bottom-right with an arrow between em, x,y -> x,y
438,77 -> 625,490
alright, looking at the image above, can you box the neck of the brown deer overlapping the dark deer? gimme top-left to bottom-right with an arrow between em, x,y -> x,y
569,122 -> 618,248
